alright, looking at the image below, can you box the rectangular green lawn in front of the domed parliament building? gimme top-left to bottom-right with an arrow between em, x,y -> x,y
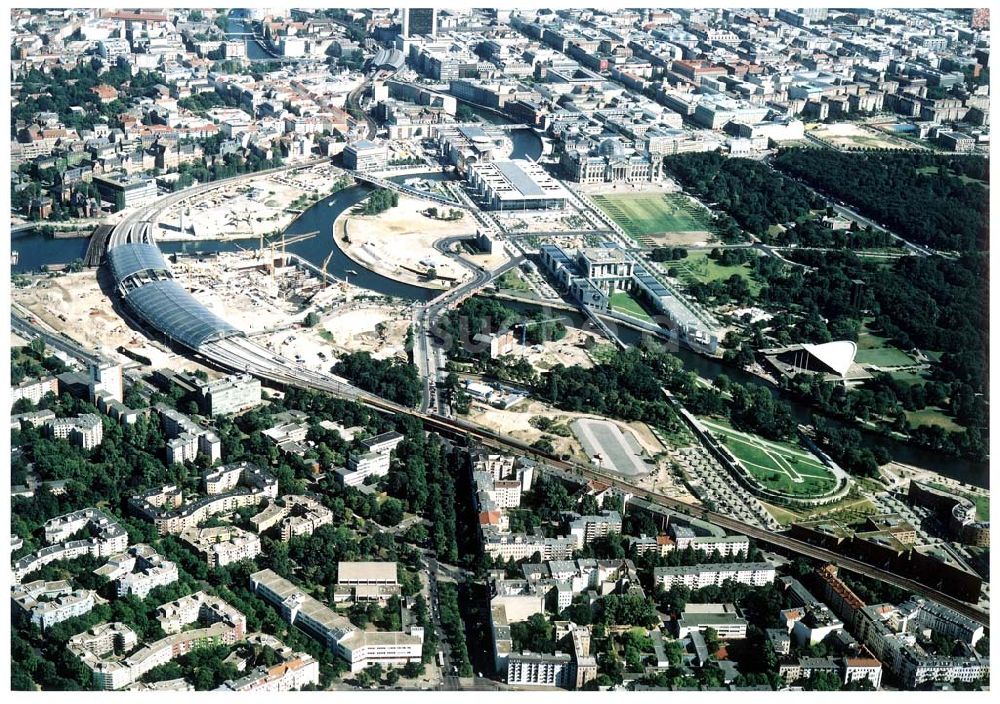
591,193 -> 709,244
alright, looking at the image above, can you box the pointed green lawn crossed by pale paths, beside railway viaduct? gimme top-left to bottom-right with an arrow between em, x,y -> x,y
702,419 -> 837,497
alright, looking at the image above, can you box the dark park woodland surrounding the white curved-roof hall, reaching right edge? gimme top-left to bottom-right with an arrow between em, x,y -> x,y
752,251 -> 989,458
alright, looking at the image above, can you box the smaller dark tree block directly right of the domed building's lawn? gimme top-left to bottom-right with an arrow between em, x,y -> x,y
663,152 -> 824,235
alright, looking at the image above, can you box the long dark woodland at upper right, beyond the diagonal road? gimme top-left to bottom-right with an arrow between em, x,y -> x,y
774,149 -> 989,251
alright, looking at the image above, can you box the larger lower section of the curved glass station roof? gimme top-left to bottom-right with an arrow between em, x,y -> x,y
124,278 -> 243,349
